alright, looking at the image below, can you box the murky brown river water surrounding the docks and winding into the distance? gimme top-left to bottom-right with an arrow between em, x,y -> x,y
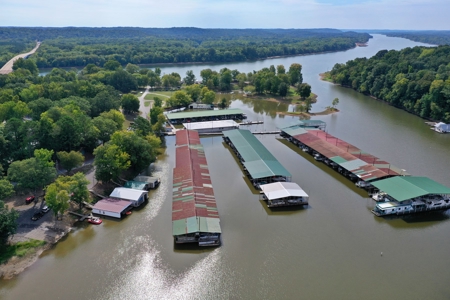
0,36 -> 450,300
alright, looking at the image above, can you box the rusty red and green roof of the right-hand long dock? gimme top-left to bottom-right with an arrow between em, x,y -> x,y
282,125 -> 409,182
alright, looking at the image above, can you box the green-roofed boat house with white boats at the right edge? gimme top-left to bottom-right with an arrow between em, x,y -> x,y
372,176 -> 450,217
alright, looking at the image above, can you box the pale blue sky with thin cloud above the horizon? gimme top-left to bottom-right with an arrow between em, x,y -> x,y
0,0 -> 450,30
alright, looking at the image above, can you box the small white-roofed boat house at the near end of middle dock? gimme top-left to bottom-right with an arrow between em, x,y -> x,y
260,182 -> 309,207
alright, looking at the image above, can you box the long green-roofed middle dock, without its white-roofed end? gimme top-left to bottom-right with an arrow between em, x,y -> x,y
223,129 -> 292,189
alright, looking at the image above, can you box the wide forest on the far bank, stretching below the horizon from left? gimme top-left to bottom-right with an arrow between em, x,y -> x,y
0,27 -> 370,68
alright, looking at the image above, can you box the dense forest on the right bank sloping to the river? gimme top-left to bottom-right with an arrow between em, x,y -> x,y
326,46 -> 450,123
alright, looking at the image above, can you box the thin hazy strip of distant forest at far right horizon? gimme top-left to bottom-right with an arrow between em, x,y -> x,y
377,30 -> 450,45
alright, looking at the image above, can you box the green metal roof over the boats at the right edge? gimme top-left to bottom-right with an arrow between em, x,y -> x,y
372,176 -> 450,202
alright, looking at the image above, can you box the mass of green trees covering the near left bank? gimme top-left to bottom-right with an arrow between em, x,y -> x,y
0,59 -> 165,247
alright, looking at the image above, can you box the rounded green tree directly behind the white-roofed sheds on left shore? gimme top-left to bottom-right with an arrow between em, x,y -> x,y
94,143 -> 130,182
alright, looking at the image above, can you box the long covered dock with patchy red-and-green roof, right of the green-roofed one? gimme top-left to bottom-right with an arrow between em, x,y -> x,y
280,121 -> 409,189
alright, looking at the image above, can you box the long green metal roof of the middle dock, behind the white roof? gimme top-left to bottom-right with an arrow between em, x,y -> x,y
223,129 -> 292,179
